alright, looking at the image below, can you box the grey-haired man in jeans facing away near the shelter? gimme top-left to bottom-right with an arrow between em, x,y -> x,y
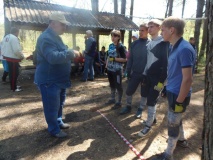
81,30 -> 96,82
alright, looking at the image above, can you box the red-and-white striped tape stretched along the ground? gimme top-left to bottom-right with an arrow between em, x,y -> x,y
97,110 -> 145,160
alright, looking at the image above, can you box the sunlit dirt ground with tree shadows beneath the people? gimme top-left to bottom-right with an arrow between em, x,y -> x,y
0,70 -> 204,160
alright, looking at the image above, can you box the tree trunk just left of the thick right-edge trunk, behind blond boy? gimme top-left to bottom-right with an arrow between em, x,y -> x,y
194,0 -> 204,53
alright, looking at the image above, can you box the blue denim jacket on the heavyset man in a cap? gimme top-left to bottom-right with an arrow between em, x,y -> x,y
34,28 -> 74,88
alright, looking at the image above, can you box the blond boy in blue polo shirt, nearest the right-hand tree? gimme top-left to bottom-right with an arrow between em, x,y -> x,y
153,17 -> 196,160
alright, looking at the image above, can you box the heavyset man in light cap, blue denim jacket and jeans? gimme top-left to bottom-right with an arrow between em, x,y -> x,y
35,13 -> 78,138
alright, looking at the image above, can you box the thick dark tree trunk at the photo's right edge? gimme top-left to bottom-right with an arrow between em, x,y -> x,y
202,0 -> 213,160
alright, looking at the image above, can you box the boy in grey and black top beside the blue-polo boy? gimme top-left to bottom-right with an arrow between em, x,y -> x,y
136,19 -> 169,137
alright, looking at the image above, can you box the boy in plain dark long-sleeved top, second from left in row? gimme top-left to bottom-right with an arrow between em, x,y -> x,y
120,24 -> 149,117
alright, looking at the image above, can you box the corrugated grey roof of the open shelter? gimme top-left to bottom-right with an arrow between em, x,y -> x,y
4,0 -> 138,30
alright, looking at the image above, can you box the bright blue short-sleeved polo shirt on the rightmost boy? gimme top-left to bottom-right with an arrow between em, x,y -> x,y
166,38 -> 196,96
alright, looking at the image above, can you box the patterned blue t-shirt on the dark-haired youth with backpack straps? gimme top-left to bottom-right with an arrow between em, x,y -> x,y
107,43 -> 126,72
